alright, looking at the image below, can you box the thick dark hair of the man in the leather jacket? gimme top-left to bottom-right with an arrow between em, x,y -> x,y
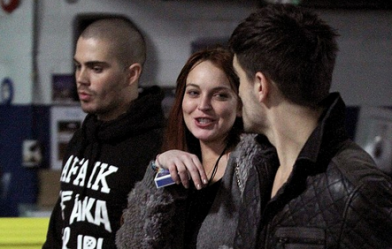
229,4 -> 338,107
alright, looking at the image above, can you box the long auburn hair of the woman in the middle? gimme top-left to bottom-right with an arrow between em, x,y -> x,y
162,45 -> 242,157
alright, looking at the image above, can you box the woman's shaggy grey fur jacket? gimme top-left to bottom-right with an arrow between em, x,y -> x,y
116,134 -> 276,249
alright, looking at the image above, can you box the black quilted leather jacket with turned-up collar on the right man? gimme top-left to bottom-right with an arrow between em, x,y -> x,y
235,93 -> 392,249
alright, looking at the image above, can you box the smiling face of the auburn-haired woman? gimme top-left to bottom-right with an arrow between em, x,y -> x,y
182,61 -> 239,143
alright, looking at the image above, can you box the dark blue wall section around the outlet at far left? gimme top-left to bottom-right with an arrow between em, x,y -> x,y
0,105 -> 50,217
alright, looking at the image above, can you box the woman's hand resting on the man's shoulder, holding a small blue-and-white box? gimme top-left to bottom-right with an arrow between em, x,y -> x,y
155,150 -> 208,189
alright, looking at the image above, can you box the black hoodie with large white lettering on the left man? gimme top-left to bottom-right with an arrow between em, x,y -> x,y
43,87 -> 164,249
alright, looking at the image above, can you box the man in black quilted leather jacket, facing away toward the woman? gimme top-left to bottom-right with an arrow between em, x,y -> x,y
230,4 -> 392,249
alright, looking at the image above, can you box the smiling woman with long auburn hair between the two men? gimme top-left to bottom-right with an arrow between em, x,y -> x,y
116,46 -> 274,249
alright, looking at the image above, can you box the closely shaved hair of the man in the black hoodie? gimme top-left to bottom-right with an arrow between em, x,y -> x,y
80,17 -> 146,67
